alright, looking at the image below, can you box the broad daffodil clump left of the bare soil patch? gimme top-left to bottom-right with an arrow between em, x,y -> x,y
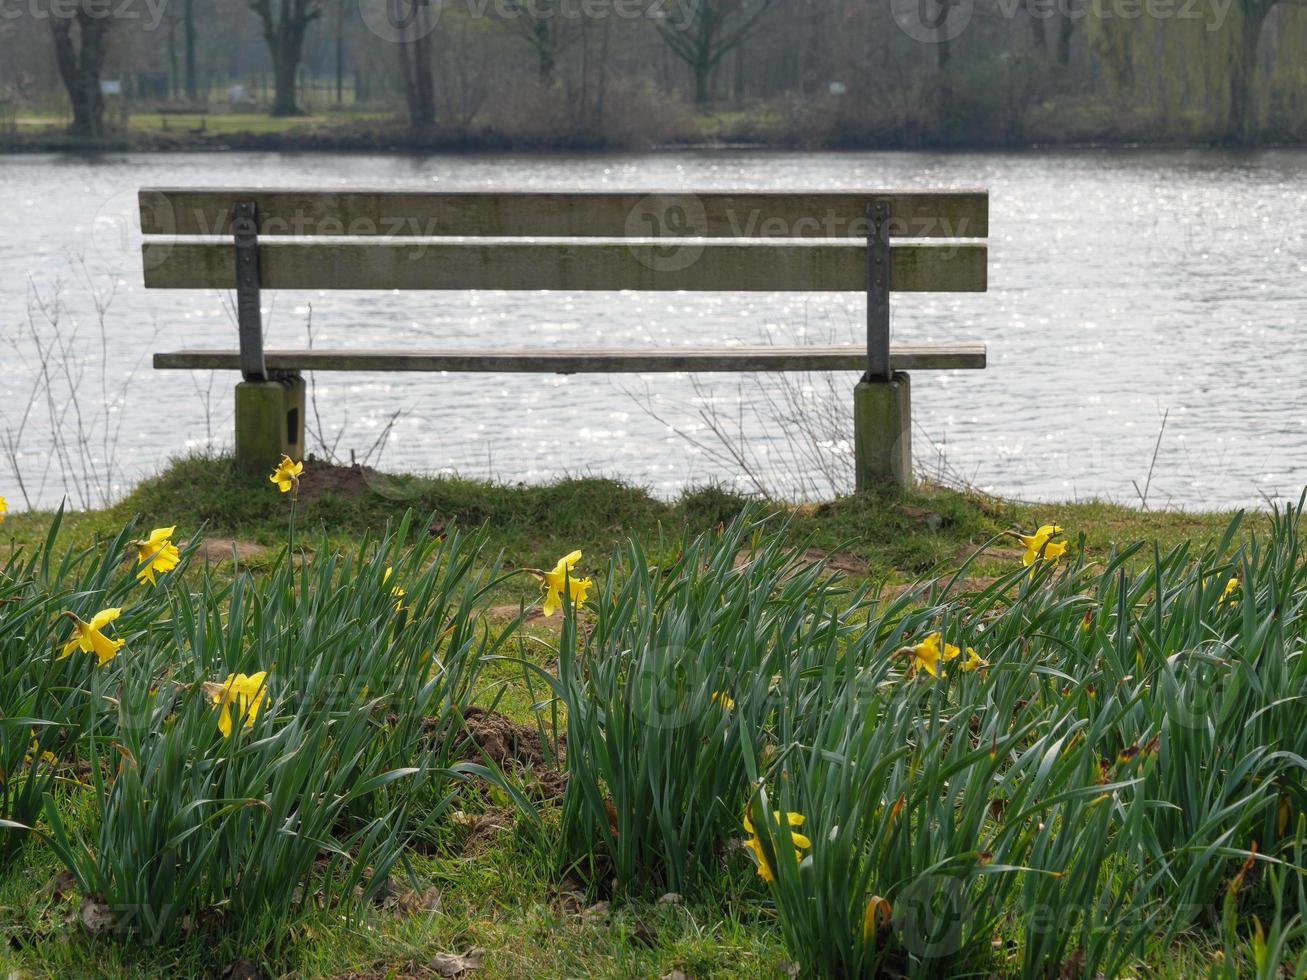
34,519 -> 511,942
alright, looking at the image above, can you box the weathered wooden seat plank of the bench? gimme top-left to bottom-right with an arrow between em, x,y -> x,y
154,344 -> 985,374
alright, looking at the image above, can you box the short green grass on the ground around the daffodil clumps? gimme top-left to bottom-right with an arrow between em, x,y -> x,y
0,459 -> 1286,977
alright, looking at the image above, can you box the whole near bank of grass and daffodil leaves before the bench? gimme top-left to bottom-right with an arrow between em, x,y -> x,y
0,459 -> 1291,979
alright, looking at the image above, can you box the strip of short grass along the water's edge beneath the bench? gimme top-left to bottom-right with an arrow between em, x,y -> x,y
0,457 -> 1256,595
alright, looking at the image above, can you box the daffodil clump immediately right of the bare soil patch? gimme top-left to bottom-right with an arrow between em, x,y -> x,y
541,517 -> 873,892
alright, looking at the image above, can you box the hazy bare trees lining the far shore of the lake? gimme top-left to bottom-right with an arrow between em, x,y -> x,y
0,0 -> 1307,148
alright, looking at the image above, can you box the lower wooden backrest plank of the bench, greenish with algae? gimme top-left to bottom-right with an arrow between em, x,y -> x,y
142,242 -> 985,293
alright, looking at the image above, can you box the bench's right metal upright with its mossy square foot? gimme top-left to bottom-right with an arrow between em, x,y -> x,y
853,200 -> 912,490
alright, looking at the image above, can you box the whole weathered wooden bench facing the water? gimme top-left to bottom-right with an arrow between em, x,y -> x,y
140,188 -> 989,487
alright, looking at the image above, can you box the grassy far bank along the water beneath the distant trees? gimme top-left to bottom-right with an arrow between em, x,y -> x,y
10,103 -> 1303,153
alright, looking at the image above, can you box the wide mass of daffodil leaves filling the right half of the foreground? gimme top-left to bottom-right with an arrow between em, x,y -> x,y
538,508 -> 1307,977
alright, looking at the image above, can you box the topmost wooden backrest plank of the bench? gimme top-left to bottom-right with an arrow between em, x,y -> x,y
140,188 -> 989,238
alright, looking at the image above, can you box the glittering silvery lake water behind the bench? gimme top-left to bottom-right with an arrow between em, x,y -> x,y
0,150 -> 1307,508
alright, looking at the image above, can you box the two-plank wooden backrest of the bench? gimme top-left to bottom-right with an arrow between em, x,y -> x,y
140,188 -> 988,291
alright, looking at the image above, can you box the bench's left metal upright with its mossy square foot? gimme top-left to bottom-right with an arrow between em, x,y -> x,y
231,201 -> 305,474
